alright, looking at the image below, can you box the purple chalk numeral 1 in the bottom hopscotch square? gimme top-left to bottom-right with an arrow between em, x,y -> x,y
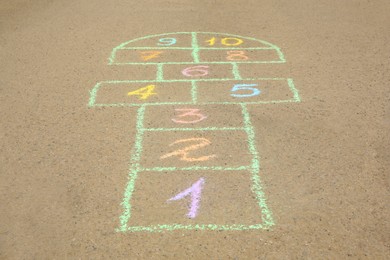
168,178 -> 205,218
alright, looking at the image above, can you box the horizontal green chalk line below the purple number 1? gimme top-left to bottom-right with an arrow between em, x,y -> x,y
127,223 -> 271,232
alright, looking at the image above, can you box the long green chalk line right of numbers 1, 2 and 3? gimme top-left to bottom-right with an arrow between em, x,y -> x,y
241,104 -> 274,226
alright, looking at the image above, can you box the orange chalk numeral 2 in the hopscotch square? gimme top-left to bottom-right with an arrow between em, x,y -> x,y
160,138 -> 216,162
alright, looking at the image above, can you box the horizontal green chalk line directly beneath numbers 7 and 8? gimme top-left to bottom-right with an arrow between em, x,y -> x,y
108,60 -> 286,65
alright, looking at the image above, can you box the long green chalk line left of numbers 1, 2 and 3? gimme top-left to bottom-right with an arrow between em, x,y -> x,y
119,106 -> 145,231
